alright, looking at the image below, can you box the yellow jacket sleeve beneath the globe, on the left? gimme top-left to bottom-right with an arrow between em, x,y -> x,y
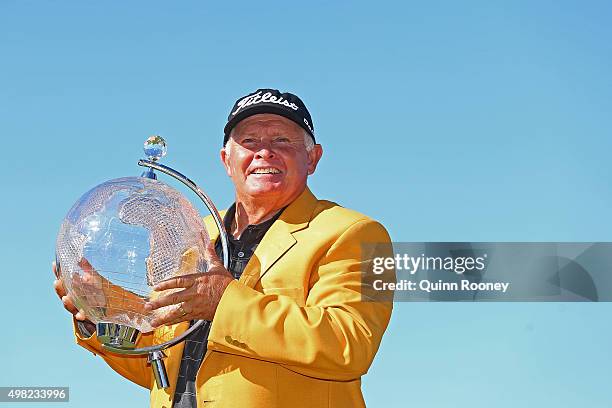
72,318 -> 153,389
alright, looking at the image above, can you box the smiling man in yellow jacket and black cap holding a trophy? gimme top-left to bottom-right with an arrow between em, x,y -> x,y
55,89 -> 391,408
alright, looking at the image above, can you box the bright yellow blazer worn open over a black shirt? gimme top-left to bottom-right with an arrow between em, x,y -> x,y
75,188 -> 392,408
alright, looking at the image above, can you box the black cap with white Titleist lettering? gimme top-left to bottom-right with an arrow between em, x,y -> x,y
223,89 -> 316,146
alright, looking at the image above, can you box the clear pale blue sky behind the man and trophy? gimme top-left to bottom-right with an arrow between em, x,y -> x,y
0,0 -> 612,408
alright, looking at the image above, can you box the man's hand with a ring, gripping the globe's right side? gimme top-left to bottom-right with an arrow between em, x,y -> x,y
145,243 -> 234,327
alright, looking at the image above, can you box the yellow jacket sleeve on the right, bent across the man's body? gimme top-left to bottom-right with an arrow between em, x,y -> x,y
209,219 -> 394,381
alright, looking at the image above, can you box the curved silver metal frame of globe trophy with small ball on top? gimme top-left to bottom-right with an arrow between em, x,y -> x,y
97,136 -> 229,388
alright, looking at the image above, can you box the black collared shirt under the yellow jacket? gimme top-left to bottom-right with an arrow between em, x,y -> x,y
173,204 -> 283,408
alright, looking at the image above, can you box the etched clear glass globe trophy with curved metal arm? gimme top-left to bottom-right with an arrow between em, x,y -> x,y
56,135 -> 229,388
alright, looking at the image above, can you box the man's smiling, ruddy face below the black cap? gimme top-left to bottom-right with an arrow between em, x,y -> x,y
221,113 -> 322,206
